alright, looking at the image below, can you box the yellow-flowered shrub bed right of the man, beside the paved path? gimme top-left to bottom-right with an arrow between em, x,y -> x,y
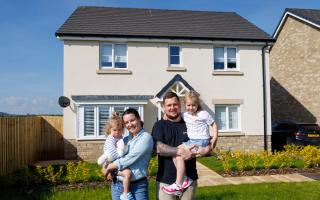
198,145 -> 320,176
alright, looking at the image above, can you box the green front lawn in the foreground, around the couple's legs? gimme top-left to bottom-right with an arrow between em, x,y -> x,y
0,181 -> 320,200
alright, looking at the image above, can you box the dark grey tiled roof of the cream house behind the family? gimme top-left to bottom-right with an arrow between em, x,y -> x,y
56,7 -> 272,41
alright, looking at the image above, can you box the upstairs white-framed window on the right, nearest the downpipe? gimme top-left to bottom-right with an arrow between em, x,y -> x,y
213,47 -> 239,71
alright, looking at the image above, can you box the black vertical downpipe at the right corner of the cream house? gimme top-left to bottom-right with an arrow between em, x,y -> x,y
261,43 -> 270,151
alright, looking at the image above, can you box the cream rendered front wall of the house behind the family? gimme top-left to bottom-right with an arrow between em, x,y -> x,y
64,41 -> 270,139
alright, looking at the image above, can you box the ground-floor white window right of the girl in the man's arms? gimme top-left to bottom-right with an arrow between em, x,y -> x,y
215,105 -> 240,131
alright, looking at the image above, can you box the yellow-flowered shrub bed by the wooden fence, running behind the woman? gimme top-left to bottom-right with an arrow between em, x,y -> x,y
0,157 -> 157,189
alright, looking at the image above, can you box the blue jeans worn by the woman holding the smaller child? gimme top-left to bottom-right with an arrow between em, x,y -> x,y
111,179 -> 149,200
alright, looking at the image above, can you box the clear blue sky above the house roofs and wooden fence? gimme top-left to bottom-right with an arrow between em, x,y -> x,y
0,0 -> 320,115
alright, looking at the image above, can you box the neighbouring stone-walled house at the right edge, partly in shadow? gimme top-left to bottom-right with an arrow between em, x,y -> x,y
270,9 -> 320,123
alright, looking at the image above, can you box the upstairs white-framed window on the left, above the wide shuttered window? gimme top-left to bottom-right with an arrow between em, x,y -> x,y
100,44 -> 127,69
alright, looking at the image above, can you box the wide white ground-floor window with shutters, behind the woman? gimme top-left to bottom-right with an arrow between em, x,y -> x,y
77,105 -> 143,139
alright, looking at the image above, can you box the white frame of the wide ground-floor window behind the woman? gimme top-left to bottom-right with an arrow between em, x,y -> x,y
76,103 -> 144,140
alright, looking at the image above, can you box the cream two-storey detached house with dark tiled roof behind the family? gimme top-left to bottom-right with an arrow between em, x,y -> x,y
56,7 -> 274,161
